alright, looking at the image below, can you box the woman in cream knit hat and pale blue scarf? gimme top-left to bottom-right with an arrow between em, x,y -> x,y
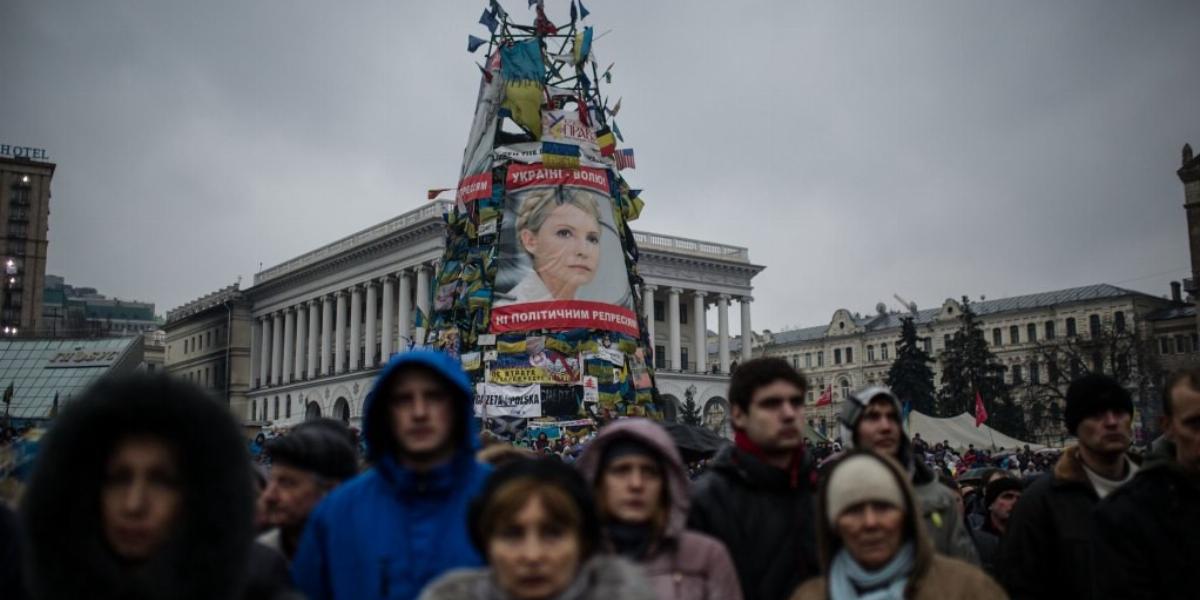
792,450 -> 1008,600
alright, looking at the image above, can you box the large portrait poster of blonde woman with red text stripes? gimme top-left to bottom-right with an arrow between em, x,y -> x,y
492,163 -> 638,336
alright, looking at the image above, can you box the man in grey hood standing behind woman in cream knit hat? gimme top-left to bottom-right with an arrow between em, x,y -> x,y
839,386 -> 979,564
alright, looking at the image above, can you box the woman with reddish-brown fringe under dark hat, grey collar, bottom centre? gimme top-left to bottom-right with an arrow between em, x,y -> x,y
420,458 -> 655,600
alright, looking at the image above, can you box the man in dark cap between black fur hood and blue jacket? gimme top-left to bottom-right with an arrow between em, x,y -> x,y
258,419 -> 359,563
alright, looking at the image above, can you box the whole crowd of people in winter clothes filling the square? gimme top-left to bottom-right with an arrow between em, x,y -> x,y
0,350 -> 1200,600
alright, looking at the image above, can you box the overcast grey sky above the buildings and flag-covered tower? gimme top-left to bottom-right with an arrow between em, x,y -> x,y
0,0 -> 1200,330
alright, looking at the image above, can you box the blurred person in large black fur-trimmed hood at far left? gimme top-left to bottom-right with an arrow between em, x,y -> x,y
22,373 -> 295,600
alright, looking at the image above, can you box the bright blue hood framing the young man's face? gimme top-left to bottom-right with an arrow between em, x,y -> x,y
362,349 -> 479,462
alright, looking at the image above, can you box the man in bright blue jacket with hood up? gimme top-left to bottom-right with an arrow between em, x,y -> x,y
292,350 -> 490,600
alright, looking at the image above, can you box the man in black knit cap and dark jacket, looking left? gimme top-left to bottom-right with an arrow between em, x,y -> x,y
996,374 -> 1138,600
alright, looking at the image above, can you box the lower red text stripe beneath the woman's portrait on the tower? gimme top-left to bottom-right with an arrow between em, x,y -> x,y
492,300 -> 638,337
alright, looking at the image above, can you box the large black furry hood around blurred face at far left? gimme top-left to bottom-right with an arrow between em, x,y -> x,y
22,374 -> 254,600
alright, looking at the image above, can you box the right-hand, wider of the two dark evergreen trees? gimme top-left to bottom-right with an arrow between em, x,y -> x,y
938,296 -> 1025,439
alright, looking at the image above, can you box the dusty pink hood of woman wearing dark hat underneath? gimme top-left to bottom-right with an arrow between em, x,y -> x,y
576,419 -> 691,539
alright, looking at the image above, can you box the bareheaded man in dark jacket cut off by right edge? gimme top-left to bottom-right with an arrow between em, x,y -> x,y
1094,368 -> 1200,600
